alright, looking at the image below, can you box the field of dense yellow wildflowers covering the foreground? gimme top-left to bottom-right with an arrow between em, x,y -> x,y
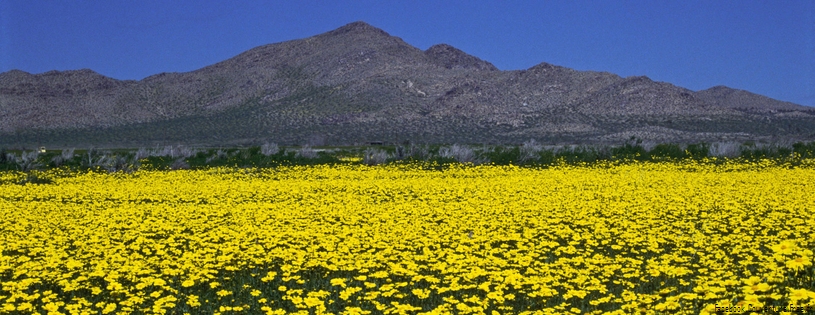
0,161 -> 815,314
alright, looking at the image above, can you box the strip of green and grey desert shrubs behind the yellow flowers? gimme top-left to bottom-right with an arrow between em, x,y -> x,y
0,138 -> 815,178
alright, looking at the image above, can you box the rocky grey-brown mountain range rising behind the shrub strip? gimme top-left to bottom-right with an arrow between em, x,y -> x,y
0,22 -> 815,146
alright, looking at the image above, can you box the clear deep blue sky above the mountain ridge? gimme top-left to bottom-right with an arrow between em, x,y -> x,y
0,0 -> 815,106
